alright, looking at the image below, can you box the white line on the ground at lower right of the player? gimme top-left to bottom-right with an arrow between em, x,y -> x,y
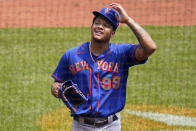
125,110 -> 196,127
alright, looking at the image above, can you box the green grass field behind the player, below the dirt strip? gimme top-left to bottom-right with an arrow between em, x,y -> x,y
0,26 -> 196,131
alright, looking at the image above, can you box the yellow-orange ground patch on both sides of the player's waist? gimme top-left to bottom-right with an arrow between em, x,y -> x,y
35,104 -> 196,131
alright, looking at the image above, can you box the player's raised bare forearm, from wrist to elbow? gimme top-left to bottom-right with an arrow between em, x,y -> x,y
126,18 -> 157,56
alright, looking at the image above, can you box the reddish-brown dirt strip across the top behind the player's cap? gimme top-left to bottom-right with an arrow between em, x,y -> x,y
0,0 -> 196,27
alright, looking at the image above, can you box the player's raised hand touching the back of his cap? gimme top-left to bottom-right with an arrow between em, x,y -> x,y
110,3 -> 130,24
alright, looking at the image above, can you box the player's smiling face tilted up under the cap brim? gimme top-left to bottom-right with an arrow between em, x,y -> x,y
91,17 -> 115,42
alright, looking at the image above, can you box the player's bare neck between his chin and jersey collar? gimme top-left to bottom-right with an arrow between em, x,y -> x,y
90,40 -> 109,56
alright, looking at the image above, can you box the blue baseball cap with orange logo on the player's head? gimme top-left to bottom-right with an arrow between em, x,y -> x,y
93,7 -> 119,29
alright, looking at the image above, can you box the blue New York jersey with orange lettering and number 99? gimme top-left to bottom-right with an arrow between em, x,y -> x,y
51,42 -> 147,117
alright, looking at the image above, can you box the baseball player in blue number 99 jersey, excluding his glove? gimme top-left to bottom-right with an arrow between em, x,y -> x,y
51,3 -> 156,131
